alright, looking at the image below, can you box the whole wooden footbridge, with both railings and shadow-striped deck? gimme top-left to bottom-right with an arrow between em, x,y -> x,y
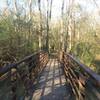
0,51 -> 100,100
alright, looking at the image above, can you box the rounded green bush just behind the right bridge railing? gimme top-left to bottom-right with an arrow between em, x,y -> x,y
72,42 -> 95,65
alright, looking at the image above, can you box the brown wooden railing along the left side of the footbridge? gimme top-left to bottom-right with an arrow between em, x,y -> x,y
0,51 -> 48,100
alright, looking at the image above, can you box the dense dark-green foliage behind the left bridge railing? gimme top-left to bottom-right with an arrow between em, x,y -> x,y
0,15 -> 38,66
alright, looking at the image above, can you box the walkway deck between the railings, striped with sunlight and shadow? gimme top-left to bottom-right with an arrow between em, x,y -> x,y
32,59 -> 72,100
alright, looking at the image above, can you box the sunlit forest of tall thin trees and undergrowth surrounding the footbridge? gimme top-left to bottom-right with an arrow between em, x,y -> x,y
0,0 -> 100,74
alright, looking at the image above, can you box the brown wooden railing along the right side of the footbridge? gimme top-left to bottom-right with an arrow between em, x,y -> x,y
62,53 -> 100,100
